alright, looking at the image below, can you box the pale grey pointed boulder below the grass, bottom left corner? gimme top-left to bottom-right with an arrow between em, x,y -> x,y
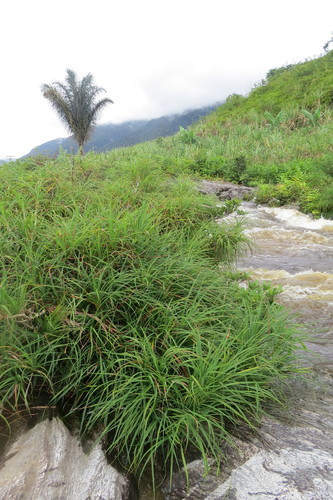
0,418 -> 129,500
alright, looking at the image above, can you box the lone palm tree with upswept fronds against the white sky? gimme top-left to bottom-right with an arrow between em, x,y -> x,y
41,69 -> 113,154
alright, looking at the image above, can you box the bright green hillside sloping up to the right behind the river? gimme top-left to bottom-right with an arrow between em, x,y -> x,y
119,51 -> 333,217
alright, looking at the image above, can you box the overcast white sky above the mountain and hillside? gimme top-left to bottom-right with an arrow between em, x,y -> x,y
0,0 -> 333,158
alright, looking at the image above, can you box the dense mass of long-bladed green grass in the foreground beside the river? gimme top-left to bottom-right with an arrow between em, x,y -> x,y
0,154 -> 299,486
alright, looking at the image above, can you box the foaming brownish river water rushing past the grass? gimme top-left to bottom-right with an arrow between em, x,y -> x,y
239,203 -> 333,374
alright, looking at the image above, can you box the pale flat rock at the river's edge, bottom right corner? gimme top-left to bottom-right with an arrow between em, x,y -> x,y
164,394 -> 333,500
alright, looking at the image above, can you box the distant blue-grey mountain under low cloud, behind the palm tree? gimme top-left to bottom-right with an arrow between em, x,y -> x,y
23,103 -> 221,158
